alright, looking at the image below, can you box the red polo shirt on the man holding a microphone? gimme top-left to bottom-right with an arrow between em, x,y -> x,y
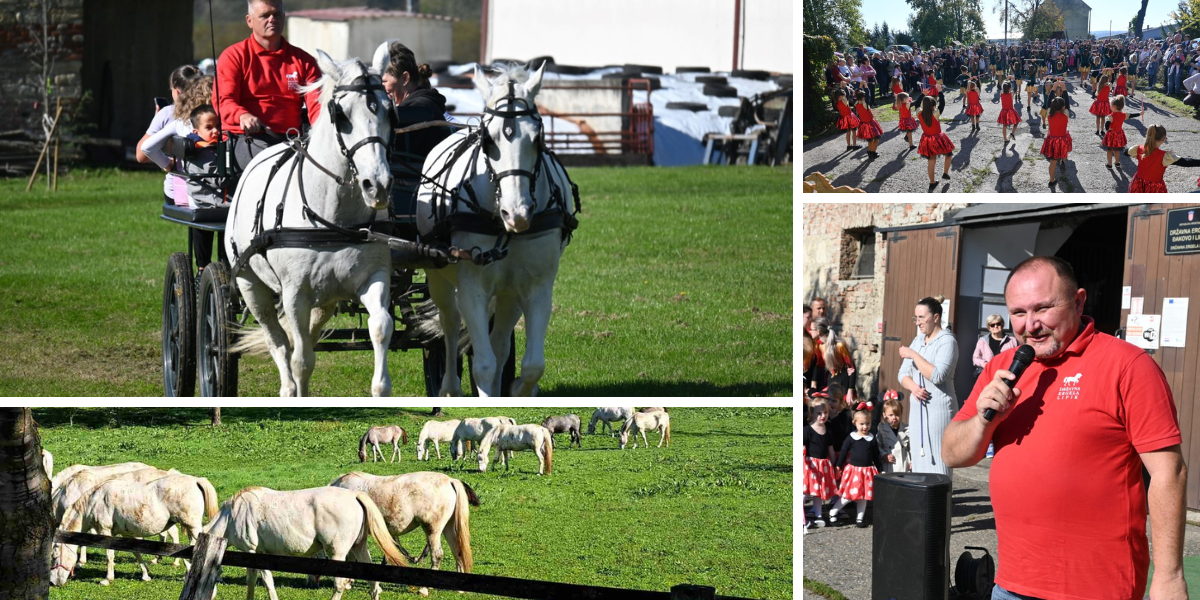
954,317 -> 1181,600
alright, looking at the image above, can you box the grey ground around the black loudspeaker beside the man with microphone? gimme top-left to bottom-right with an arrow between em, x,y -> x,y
803,460 -> 1200,600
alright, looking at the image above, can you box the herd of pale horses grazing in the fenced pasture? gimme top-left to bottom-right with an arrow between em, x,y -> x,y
42,407 -> 671,600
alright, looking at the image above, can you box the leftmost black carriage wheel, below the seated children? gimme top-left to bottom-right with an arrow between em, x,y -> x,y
162,252 -> 196,397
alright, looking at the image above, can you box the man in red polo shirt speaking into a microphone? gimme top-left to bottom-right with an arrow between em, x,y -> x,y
942,257 -> 1188,600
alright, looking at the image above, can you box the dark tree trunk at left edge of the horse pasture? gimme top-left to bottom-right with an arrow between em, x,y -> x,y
0,408 -> 55,600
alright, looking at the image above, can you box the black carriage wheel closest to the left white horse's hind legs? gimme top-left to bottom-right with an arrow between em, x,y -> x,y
196,263 -> 238,397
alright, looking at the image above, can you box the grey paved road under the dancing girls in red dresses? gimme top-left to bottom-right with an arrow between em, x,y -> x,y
803,74 -> 1200,193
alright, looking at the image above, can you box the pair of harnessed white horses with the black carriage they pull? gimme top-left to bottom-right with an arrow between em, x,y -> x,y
162,48 -> 578,396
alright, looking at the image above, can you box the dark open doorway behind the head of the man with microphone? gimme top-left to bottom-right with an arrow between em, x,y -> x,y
1043,210 -> 1128,335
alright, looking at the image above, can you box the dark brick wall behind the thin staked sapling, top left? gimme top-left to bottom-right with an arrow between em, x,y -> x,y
0,0 -> 84,132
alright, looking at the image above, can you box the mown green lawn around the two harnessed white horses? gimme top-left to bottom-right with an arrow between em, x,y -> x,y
0,167 -> 793,396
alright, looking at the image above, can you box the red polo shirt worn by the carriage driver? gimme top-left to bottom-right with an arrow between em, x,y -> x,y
212,36 -> 322,134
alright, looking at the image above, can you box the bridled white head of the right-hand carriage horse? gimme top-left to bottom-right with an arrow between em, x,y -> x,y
474,64 -> 546,233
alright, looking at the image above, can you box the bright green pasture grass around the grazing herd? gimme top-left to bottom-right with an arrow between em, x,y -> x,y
34,408 -> 793,600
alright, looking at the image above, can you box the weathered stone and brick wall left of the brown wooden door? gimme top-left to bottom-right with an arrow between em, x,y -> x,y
802,203 -> 967,397
